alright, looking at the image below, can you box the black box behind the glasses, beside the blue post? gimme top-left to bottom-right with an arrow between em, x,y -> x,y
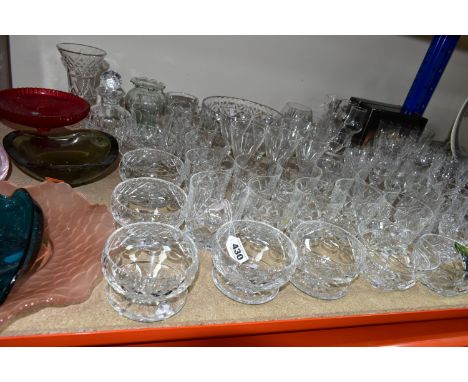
351,97 -> 427,145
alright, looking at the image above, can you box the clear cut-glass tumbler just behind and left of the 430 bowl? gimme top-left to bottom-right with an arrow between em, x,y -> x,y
185,171 -> 232,248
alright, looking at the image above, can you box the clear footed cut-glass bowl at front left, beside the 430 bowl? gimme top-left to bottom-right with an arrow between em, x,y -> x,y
102,223 -> 199,322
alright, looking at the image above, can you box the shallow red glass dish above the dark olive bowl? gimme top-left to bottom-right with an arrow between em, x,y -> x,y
0,88 -> 90,129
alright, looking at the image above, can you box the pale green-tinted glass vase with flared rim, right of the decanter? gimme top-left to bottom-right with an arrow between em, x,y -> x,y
125,77 -> 167,132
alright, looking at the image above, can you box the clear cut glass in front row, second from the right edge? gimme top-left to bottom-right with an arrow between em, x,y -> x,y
358,218 -> 417,291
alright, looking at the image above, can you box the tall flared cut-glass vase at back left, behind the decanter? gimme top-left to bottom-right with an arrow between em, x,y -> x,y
57,43 -> 106,105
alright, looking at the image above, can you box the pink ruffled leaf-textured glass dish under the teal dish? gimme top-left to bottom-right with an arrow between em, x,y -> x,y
0,181 -> 114,328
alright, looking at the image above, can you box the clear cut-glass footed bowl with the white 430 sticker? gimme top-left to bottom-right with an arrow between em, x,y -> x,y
212,220 -> 297,304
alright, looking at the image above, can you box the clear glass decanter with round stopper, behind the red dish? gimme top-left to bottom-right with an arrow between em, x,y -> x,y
86,70 -> 135,151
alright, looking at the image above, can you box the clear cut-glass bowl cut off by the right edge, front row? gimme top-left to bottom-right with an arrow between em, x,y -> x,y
414,234 -> 468,297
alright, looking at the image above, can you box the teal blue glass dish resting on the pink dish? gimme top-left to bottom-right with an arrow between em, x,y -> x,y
0,188 -> 44,305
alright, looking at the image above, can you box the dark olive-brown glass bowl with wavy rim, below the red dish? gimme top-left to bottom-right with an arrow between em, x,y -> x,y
3,129 -> 119,187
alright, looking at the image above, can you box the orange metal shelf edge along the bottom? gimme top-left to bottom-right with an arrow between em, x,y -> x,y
0,308 -> 468,346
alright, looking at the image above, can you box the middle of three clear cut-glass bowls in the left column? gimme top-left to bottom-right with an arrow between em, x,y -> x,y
111,177 -> 187,227
